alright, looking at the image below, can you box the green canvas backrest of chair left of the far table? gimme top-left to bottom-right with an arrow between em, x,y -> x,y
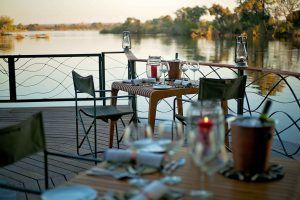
72,70 -> 95,97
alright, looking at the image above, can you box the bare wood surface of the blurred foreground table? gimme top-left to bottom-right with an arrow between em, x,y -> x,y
68,149 -> 300,200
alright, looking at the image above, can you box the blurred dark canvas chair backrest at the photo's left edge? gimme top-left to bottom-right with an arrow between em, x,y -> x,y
0,112 -> 46,167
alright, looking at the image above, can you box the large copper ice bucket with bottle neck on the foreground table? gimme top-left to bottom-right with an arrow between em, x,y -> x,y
231,102 -> 274,174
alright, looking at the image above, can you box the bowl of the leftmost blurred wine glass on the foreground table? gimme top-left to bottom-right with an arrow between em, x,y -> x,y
124,123 -> 153,150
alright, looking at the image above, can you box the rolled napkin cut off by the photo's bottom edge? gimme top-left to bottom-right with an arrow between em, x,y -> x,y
131,181 -> 168,200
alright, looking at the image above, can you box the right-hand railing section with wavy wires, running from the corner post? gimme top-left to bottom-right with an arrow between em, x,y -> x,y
128,55 -> 300,159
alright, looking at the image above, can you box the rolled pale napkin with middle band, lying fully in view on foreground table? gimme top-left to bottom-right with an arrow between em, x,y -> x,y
104,149 -> 164,168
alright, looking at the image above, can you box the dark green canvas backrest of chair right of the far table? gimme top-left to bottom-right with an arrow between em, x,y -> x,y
198,75 -> 247,114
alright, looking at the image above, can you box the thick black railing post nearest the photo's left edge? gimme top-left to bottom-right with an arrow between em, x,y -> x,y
8,56 -> 17,101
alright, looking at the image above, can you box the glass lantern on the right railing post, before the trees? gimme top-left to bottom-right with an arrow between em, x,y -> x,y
234,35 -> 248,67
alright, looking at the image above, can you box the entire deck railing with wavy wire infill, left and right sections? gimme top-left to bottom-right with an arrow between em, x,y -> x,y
0,51 -> 300,158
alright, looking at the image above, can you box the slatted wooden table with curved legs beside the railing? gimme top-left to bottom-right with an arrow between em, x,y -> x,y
109,81 -> 199,148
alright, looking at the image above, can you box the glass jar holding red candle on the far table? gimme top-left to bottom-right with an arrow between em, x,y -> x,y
146,56 -> 161,81
